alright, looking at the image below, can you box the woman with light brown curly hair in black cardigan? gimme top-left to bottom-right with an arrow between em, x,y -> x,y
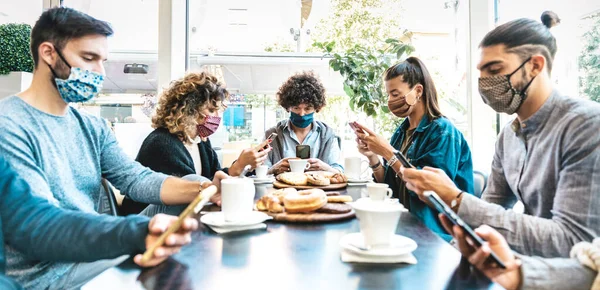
121,72 -> 269,214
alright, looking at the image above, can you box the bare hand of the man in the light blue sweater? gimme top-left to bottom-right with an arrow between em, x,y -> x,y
160,177 -> 201,205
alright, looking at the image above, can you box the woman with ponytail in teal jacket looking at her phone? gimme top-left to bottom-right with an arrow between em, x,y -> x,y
356,57 -> 473,241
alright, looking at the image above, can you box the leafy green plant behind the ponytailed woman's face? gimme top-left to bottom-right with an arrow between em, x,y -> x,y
313,31 -> 414,116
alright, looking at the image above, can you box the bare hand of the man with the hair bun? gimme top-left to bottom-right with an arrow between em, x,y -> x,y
400,166 -> 461,205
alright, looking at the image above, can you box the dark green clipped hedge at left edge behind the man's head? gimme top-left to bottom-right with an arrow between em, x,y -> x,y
0,23 -> 33,75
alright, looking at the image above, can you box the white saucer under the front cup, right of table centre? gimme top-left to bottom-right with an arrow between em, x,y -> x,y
340,233 -> 417,257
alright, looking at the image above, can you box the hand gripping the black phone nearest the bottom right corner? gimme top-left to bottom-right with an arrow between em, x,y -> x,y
439,214 -> 521,289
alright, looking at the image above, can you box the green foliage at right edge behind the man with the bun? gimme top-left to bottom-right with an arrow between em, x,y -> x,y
579,13 -> 600,102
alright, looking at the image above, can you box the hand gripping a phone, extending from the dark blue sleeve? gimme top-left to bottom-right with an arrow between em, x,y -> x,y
133,214 -> 198,267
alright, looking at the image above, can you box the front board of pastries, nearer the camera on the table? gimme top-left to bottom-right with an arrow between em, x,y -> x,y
255,188 -> 354,223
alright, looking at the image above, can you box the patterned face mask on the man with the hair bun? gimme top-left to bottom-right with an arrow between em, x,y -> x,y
479,57 -> 535,115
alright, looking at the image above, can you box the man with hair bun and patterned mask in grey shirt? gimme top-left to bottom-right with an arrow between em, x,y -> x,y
403,14 -> 600,258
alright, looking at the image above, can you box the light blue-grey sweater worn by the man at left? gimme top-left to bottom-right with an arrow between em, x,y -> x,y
0,96 -> 167,289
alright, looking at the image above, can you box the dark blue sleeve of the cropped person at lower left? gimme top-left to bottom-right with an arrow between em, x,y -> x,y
0,156 -> 148,286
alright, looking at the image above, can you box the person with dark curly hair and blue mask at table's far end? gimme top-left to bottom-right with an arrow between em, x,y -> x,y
265,72 -> 344,174
